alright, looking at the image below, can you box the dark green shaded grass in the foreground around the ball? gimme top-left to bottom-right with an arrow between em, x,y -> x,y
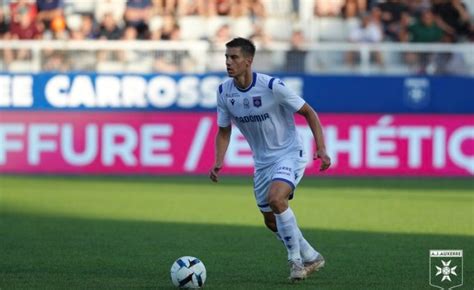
0,212 -> 474,289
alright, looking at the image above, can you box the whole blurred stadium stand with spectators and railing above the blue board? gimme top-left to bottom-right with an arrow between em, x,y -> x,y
0,0 -> 474,74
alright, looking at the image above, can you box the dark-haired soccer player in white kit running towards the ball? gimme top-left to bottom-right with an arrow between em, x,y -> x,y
209,38 -> 331,281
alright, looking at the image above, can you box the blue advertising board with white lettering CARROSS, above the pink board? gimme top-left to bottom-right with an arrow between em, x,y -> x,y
0,73 -> 474,114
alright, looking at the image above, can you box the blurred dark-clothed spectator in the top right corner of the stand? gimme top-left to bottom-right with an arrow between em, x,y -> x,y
433,0 -> 470,40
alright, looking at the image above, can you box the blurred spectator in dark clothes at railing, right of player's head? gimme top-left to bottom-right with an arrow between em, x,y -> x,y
283,30 -> 308,73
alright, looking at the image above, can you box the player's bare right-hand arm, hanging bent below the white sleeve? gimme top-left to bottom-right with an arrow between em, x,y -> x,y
297,103 -> 331,171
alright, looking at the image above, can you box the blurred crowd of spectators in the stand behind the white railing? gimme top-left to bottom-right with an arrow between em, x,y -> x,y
0,0 -> 474,72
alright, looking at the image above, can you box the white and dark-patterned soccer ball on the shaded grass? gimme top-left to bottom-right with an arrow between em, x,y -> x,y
171,256 -> 206,288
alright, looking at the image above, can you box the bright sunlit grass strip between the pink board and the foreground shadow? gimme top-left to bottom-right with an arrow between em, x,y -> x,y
0,176 -> 474,235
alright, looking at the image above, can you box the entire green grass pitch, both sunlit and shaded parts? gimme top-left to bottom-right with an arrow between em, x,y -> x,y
0,176 -> 474,290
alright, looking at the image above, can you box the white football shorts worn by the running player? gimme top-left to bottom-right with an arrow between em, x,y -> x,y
253,150 -> 308,212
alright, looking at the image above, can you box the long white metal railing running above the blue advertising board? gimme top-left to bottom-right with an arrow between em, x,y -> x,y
0,40 -> 474,76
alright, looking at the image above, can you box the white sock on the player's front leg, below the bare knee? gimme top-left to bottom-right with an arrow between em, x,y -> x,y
275,208 -> 302,263
